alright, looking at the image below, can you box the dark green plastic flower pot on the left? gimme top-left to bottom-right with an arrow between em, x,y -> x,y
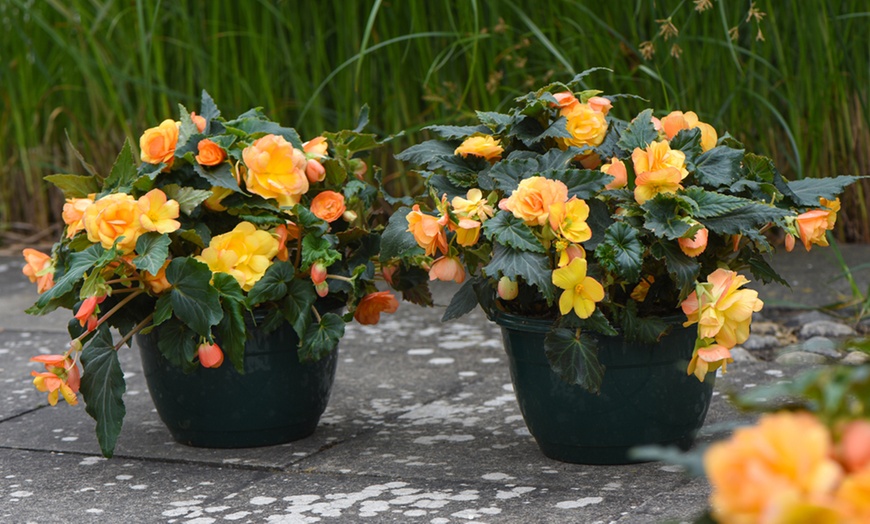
136,318 -> 337,448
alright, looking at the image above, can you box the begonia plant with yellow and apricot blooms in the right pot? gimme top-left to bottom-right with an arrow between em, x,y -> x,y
381,70 -> 856,392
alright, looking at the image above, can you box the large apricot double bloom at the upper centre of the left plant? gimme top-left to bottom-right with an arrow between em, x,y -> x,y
242,135 -> 308,207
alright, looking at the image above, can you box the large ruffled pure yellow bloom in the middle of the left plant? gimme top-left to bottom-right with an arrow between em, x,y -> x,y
196,222 -> 278,291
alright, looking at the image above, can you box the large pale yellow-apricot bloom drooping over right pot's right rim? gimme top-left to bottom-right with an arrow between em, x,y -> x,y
681,268 -> 764,348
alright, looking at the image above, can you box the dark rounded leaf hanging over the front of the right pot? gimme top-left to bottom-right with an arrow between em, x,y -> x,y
544,328 -> 604,394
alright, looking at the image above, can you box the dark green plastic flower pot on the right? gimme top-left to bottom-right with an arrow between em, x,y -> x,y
495,314 -> 715,464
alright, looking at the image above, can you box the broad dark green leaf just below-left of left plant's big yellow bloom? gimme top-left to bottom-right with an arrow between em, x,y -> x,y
166,257 -> 223,338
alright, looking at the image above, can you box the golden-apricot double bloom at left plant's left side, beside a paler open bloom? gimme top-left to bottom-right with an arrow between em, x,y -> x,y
82,190 -> 143,254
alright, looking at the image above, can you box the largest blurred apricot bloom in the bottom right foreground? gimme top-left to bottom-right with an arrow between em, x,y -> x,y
704,412 -> 843,523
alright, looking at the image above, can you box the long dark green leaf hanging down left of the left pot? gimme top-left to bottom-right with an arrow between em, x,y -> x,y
81,325 -> 127,458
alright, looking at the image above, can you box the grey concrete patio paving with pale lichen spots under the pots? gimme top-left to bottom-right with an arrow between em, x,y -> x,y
0,246 -> 870,524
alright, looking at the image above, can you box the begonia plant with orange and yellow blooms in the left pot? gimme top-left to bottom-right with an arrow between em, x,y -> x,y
24,92 -> 398,456
